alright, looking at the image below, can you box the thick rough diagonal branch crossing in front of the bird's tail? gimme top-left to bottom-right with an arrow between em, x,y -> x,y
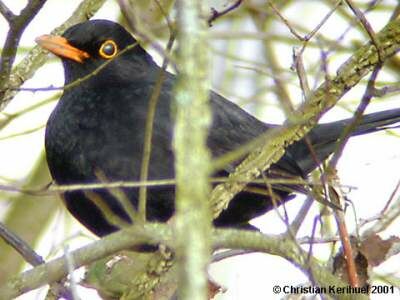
211,19 -> 400,217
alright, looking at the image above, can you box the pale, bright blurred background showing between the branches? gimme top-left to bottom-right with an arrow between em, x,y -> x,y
0,0 -> 400,300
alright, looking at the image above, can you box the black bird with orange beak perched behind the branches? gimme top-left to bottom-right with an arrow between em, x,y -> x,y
37,20 -> 400,236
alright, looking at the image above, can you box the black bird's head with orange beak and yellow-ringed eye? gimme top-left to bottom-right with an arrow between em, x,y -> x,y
36,20 -> 152,84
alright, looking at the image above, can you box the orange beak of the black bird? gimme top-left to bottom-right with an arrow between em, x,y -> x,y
35,34 -> 90,63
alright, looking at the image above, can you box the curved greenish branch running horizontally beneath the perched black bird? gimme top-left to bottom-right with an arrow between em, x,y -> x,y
0,223 -> 365,299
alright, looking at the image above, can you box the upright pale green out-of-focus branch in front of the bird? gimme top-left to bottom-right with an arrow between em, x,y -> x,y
174,0 -> 211,299
